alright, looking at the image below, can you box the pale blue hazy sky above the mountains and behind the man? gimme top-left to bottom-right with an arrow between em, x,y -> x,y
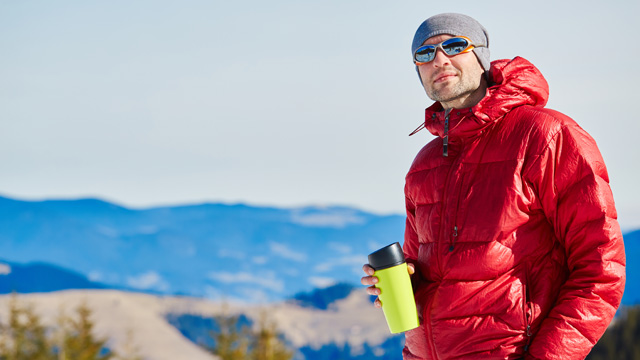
0,0 -> 640,229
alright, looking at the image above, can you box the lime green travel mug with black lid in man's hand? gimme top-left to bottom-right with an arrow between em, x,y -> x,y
369,242 -> 420,334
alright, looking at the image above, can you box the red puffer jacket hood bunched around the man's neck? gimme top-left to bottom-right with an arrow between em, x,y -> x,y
424,57 -> 549,141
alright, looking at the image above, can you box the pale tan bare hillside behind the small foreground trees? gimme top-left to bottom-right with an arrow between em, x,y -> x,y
0,289 -> 390,360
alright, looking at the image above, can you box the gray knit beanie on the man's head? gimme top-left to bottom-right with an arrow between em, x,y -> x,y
411,13 -> 491,71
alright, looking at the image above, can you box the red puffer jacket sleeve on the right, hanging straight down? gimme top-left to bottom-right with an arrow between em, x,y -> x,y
525,123 -> 625,360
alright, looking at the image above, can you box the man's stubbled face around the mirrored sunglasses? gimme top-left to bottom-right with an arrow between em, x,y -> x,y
418,34 -> 484,108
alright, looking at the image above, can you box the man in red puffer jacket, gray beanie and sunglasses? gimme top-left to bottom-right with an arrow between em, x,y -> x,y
362,14 -> 625,360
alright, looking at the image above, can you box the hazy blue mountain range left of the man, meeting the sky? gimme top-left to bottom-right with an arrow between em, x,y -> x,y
0,197 -> 404,302
